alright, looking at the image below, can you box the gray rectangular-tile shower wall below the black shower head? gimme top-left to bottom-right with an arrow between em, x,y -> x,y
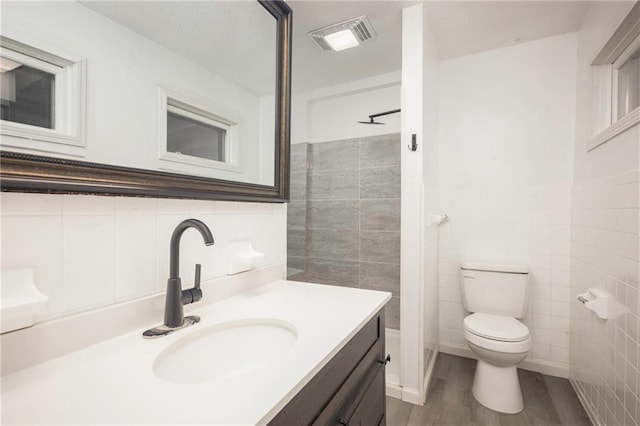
287,133 -> 400,329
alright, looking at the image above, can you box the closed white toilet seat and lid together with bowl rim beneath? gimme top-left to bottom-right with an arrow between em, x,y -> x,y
464,313 -> 531,354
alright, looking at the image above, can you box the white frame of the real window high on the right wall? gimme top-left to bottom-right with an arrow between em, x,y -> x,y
587,4 -> 640,151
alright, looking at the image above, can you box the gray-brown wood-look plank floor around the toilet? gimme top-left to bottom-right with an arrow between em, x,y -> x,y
387,353 -> 591,426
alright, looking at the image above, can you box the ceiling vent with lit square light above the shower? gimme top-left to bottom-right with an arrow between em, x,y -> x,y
307,16 -> 376,51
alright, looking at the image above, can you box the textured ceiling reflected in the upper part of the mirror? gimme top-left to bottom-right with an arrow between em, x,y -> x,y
81,0 -> 276,96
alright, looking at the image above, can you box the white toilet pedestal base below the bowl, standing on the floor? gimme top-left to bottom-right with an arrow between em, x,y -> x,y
472,359 -> 524,414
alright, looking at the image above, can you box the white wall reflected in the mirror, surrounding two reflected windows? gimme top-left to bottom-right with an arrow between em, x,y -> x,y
2,2 -> 273,185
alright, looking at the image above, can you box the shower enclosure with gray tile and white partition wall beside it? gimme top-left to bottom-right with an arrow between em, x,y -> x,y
288,12 -> 439,396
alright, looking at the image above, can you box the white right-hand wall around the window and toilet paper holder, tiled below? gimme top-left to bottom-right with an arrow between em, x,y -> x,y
570,2 -> 640,425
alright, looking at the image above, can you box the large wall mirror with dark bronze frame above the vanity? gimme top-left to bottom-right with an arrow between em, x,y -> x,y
0,0 -> 291,202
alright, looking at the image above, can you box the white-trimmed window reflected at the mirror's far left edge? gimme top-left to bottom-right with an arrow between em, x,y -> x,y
0,35 -> 85,151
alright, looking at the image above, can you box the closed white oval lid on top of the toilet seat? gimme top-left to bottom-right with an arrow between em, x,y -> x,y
464,313 -> 529,342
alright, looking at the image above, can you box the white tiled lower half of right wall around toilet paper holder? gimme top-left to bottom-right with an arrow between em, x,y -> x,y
570,170 -> 640,425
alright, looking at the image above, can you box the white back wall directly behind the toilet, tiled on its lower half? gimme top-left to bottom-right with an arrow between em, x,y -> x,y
438,34 -> 576,375
